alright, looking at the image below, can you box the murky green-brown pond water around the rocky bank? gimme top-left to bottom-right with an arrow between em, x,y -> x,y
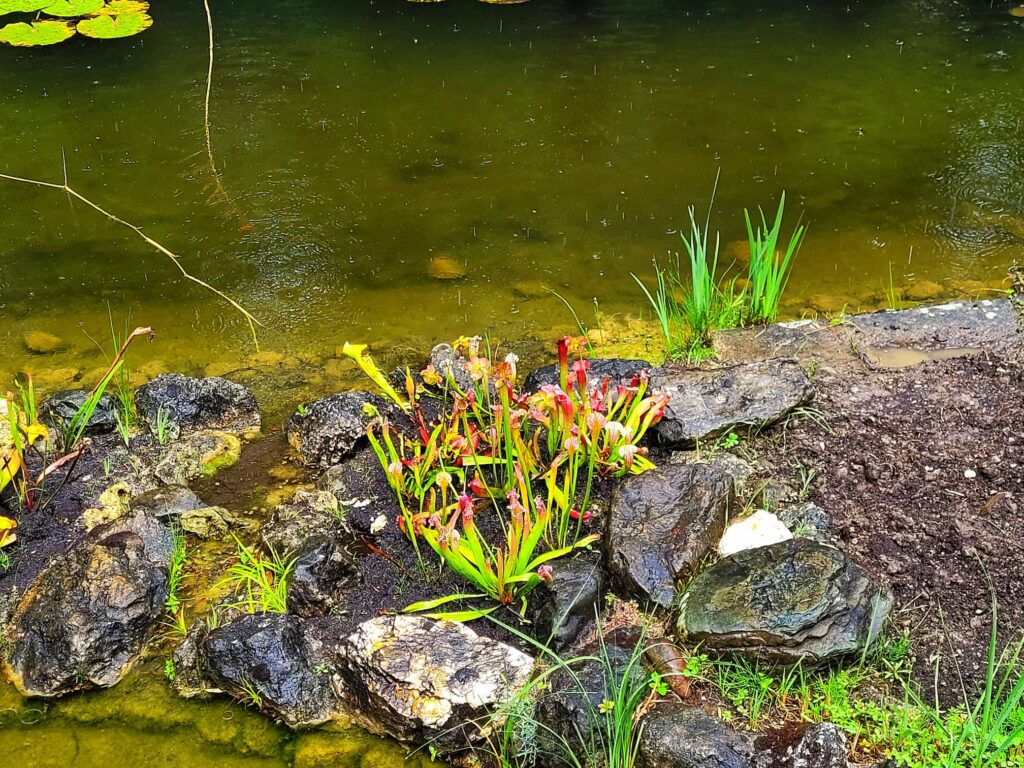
0,0 -> 1024,766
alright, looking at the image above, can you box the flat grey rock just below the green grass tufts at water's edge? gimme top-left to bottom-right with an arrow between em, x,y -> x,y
651,358 -> 812,449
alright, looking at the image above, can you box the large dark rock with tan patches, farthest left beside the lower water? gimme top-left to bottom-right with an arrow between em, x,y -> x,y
4,512 -> 172,696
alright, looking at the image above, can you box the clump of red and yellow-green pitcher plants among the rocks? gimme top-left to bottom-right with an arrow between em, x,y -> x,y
346,337 -> 668,621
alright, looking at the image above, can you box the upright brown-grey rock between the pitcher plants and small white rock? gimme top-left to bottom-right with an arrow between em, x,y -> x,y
604,463 -> 735,608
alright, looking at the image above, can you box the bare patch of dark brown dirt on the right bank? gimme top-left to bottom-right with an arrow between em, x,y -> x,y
754,355 -> 1024,701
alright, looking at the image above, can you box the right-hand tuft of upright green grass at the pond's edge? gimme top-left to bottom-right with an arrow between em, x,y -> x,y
743,191 -> 805,325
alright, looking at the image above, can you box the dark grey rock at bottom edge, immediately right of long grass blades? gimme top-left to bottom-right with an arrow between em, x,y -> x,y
638,705 -> 755,768
